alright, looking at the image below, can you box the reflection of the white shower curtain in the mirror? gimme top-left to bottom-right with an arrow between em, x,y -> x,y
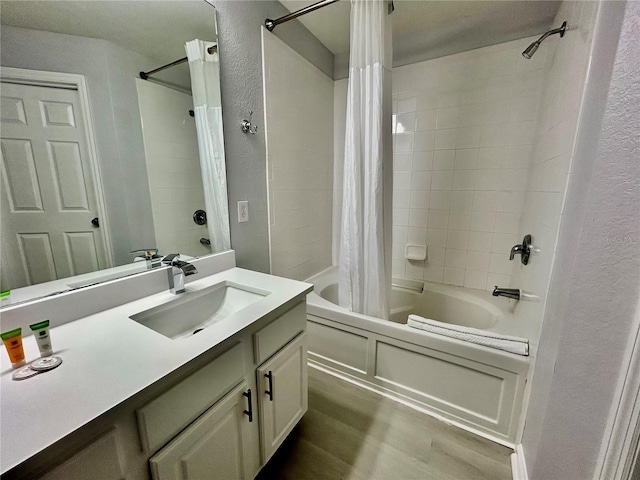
185,40 -> 231,252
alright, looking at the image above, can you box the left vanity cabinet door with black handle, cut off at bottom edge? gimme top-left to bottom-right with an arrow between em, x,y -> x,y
149,382 -> 258,480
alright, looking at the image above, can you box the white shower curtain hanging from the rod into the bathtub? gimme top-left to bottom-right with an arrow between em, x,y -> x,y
338,0 -> 389,319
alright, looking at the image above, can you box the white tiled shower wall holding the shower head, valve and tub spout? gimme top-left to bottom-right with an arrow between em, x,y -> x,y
511,1 -> 598,344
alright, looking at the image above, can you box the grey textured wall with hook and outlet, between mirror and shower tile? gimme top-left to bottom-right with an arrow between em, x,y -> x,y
209,0 -> 333,272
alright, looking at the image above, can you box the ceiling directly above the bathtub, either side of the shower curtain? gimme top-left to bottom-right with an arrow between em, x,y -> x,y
280,0 -> 559,55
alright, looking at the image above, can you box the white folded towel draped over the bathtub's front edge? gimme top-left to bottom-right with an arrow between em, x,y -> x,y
407,315 -> 529,356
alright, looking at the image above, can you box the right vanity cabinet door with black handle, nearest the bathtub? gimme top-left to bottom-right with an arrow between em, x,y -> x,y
257,333 -> 308,464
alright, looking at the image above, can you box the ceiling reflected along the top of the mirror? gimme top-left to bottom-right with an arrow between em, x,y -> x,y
0,0 -> 217,63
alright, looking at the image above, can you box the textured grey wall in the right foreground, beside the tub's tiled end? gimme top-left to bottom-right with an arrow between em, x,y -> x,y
523,1 -> 640,480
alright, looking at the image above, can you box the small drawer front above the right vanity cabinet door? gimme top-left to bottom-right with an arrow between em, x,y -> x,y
253,302 -> 307,364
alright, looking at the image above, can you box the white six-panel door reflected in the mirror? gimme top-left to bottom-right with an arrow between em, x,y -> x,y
0,82 -> 109,290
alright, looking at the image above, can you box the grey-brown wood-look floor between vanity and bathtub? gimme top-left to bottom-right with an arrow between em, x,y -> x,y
257,368 -> 512,480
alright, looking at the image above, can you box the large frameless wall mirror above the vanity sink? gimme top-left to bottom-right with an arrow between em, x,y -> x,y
0,0 -> 229,306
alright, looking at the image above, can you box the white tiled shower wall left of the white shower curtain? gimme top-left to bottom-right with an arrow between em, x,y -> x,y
262,32 -> 333,280
